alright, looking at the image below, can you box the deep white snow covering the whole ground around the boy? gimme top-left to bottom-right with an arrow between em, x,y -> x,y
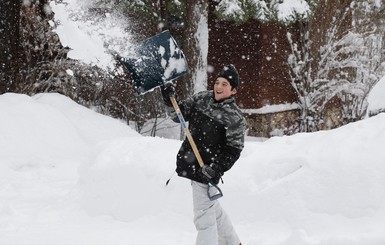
0,94 -> 385,245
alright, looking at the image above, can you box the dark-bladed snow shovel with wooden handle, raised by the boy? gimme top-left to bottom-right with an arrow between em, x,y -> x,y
120,31 -> 223,200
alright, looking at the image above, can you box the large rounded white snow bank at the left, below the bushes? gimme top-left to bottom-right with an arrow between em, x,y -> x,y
0,93 -> 138,168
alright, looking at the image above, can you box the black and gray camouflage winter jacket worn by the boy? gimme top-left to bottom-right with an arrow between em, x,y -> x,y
167,91 -> 247,183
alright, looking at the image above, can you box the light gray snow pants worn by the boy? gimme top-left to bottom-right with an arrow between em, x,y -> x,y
191,181 -> 241,245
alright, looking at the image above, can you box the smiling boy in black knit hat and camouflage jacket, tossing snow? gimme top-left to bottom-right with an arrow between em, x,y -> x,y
161,65 -> 246,245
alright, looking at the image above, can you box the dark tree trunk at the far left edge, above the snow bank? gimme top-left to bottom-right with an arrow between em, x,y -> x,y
0,0 -> 21,94
